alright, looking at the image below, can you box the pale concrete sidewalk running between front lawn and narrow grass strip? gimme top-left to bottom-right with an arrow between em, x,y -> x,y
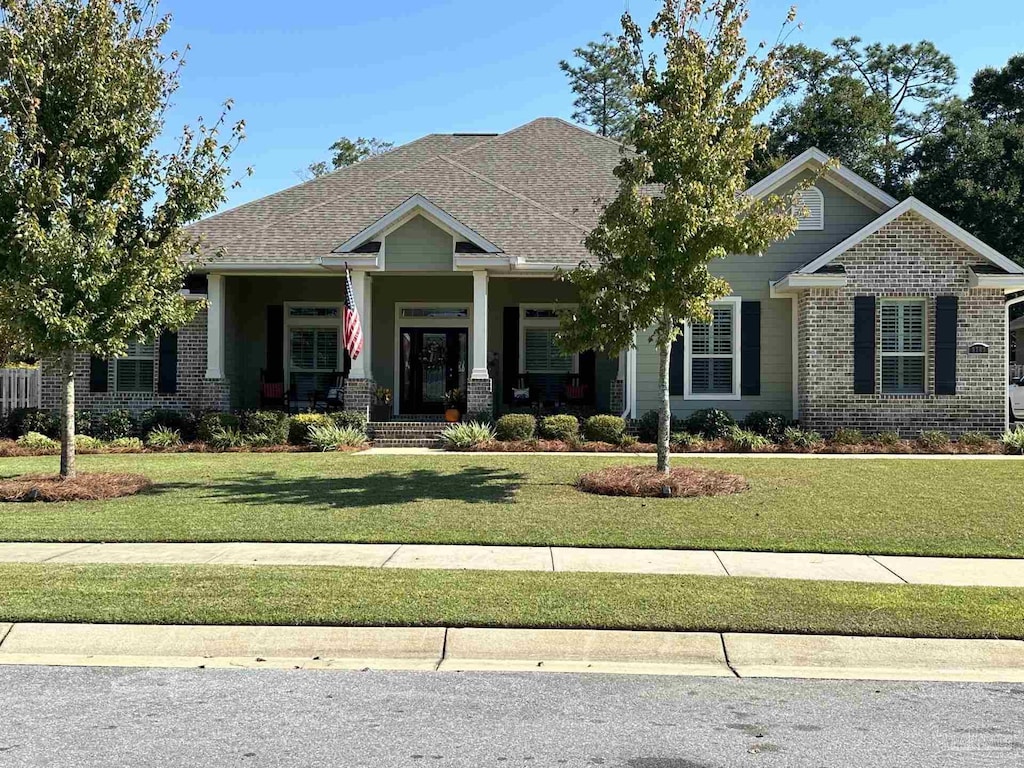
0,542 -> 1024,587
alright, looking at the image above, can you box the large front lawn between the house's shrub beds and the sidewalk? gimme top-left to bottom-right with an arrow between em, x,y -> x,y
0,454 -> 1024,557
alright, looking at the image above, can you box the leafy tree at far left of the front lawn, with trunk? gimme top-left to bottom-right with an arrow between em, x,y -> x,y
0,0 -> 244,478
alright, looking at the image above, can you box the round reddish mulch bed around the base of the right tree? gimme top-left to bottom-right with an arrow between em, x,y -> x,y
577,466 -> 750,498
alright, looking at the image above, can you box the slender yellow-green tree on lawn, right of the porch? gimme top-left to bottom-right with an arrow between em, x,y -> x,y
559,0 -> 801,472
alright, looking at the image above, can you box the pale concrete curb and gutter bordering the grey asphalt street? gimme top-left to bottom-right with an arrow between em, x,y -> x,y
0,624 -> 1024,682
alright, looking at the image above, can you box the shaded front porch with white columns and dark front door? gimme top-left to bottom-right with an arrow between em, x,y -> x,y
216,270 -> 625,419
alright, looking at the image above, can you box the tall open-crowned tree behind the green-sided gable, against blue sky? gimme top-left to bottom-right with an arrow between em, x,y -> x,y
769,37 -> 956,195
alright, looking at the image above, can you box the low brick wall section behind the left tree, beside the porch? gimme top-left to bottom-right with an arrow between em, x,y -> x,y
42,309 -> 230,414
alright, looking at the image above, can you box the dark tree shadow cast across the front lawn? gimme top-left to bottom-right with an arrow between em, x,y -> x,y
165,467 -> 524,507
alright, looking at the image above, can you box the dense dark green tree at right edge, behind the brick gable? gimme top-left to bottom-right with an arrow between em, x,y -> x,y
913,55 -> 1024,264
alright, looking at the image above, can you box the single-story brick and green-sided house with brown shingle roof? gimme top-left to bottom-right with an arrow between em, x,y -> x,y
44,118 -> 1024,433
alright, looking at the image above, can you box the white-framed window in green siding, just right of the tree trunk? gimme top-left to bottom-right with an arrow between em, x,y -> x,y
684,298 -> 740,399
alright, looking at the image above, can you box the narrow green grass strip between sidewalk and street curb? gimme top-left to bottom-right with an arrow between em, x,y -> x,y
0,564 -> 1024,638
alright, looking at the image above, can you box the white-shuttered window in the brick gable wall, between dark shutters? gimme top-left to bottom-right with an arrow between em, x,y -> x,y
882,300 -> 925,394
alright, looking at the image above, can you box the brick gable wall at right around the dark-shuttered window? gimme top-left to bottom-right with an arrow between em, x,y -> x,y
798,212 -> 1007,435
